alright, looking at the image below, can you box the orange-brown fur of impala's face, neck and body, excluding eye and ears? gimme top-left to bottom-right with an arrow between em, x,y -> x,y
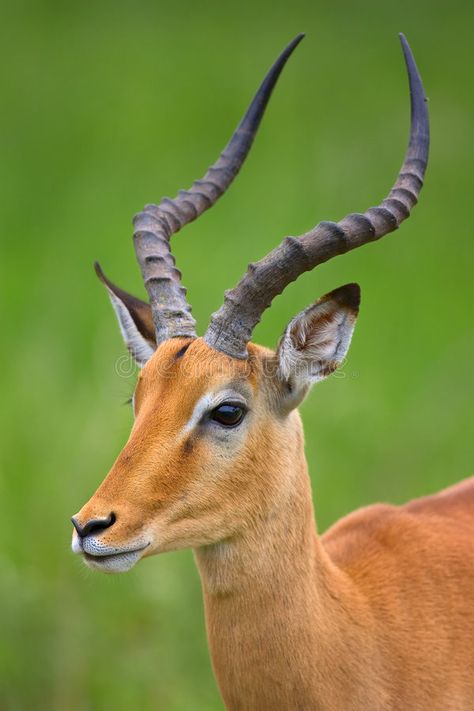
73,339 -> 474,711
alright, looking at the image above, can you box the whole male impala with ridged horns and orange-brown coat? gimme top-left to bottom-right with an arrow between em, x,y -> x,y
72,36 -> 474,711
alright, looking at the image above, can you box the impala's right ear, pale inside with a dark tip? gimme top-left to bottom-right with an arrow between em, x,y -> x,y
277,284 -> 360,408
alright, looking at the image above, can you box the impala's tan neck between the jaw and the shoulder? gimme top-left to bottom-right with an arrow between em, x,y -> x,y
196,418 -> 374,711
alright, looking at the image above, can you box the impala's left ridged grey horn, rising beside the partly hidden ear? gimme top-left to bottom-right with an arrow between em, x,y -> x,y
133,34 -> 304,344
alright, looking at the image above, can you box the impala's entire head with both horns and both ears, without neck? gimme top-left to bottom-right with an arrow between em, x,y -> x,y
73,35 -> 429,572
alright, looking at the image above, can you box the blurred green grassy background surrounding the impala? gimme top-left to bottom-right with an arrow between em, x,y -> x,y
0,0 -> 474,711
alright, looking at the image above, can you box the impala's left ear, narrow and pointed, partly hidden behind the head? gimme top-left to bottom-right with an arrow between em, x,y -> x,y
94,262 -> 156,366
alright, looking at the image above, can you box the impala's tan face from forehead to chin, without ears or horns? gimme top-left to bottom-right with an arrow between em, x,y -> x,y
74,338 -> 274,571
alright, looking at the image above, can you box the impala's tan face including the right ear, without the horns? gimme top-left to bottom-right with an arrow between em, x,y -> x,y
72,285 -> 359,572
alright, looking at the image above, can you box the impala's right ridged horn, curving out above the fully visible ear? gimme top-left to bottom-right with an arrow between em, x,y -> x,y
204,34 -> 429,358
